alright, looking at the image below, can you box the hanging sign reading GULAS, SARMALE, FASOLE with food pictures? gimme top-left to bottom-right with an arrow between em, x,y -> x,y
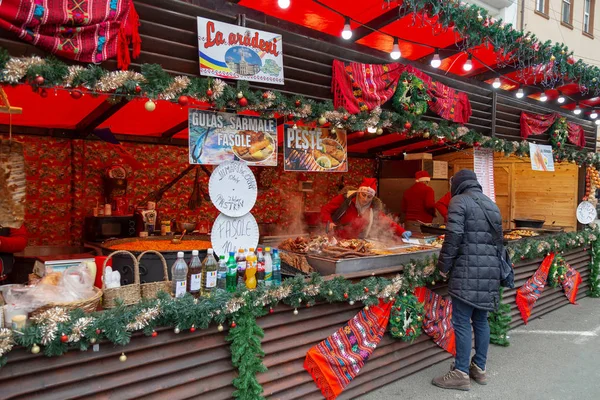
188,109 -> 277,166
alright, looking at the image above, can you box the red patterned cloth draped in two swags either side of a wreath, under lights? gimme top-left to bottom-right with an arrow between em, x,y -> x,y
331,60 -> 472,123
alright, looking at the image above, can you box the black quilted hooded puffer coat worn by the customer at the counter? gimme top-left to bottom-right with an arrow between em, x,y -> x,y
438,170 -> 502,311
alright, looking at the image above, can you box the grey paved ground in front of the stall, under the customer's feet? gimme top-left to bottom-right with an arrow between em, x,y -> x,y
360,297 -> 600,400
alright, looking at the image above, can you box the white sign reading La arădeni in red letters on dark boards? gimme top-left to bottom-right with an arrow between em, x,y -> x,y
198,17 -> 284,85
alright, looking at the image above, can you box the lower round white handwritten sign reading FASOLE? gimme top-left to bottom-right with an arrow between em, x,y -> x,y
210,213 -> 259,256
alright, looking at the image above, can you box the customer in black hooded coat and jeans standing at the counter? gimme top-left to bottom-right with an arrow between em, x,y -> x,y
432,170 -> 502,390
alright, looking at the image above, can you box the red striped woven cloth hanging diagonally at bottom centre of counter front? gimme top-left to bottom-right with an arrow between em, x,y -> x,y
304,300 -> 393,400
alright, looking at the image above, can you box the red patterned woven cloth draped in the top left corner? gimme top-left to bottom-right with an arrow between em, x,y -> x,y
0,0 -> 141,69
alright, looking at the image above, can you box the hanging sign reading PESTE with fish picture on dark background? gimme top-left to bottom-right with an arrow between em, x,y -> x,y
283,125 -> 348,172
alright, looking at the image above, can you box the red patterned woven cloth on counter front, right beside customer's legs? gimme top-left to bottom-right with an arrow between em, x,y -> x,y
415,287 -> 456,356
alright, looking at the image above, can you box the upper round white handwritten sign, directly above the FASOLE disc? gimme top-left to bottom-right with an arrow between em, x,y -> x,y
208,161 -> 258,217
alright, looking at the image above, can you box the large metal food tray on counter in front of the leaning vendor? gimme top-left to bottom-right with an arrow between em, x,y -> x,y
306,248 -> 440,275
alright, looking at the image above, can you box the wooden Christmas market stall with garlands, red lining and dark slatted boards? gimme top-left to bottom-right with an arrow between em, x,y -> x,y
0,0 -> 600,399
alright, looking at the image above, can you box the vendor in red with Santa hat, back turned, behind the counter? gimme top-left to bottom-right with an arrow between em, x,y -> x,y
402,171 -> 435,229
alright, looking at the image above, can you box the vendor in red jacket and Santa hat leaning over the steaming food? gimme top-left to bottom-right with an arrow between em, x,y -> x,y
321,178 -> 411,239
